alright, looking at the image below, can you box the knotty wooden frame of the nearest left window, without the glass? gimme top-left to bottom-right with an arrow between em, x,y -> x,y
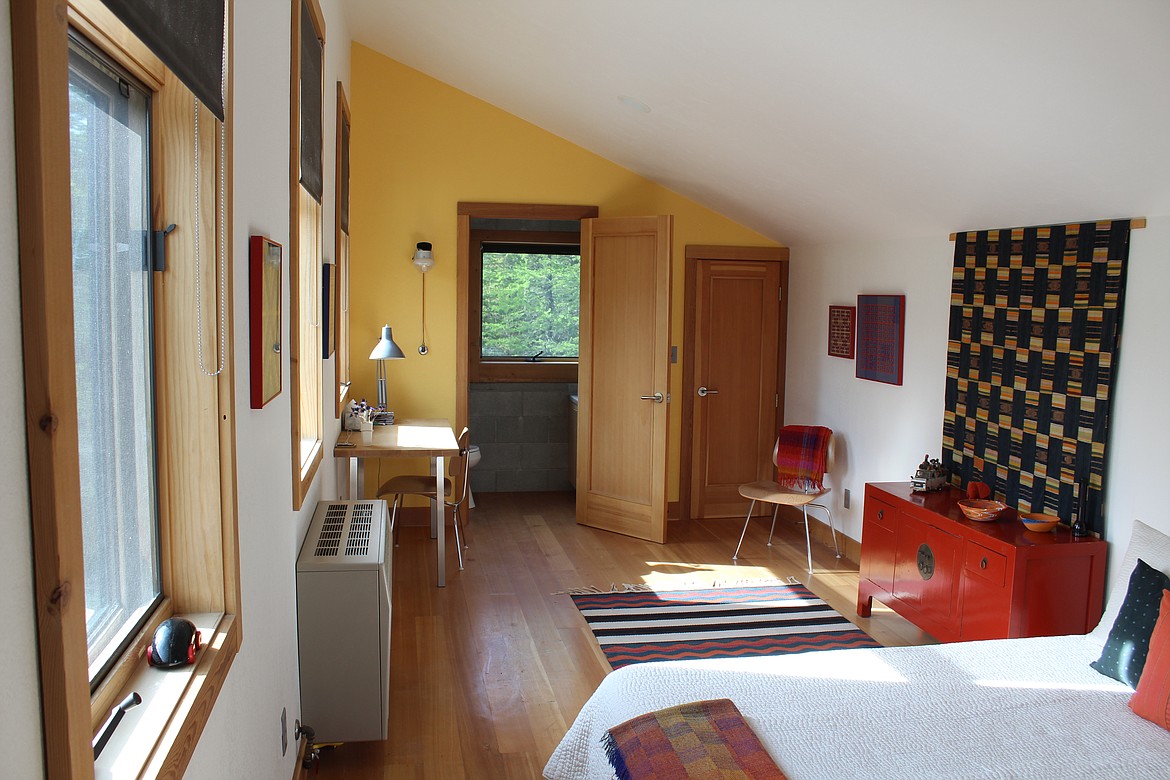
12,0 -> 242,779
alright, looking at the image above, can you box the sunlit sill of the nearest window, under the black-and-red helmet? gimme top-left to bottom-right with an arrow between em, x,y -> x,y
94,613 -> 240,780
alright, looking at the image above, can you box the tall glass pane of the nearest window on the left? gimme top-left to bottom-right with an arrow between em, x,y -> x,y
69,33 -> 160,686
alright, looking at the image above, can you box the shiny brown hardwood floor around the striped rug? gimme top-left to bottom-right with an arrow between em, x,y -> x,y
310,493 -> 931,780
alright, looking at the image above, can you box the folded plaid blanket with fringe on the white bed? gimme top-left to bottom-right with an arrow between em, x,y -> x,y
603,699 -> 785,780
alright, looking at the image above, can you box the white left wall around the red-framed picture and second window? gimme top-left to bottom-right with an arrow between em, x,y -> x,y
187,0 -> 350,780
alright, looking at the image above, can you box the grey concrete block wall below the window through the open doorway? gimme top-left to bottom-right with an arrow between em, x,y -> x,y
468,382 -> 577,492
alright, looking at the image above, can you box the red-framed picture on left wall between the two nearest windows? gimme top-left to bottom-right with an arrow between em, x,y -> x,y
248,235 -> 283,409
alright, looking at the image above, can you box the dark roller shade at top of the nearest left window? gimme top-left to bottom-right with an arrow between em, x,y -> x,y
103,0 -> 223,122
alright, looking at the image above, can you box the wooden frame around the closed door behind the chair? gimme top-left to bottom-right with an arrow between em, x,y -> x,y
679,243 -> 789,520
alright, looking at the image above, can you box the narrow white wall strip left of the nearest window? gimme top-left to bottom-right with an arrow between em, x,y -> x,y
0,0 -> 44,778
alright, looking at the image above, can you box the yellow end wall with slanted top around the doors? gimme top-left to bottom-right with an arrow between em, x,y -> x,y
350,43 -> 776,501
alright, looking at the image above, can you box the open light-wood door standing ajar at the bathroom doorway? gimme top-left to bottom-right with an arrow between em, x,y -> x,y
577,216 -> 674,543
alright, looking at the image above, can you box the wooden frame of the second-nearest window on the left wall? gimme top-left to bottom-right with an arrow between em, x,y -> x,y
289,0 -> 325,510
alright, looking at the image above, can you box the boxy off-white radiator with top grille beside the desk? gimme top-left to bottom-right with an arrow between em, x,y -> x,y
296,501 -> 393,743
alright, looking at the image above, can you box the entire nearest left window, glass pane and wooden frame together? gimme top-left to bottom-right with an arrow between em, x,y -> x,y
12,0 -> 241,778
